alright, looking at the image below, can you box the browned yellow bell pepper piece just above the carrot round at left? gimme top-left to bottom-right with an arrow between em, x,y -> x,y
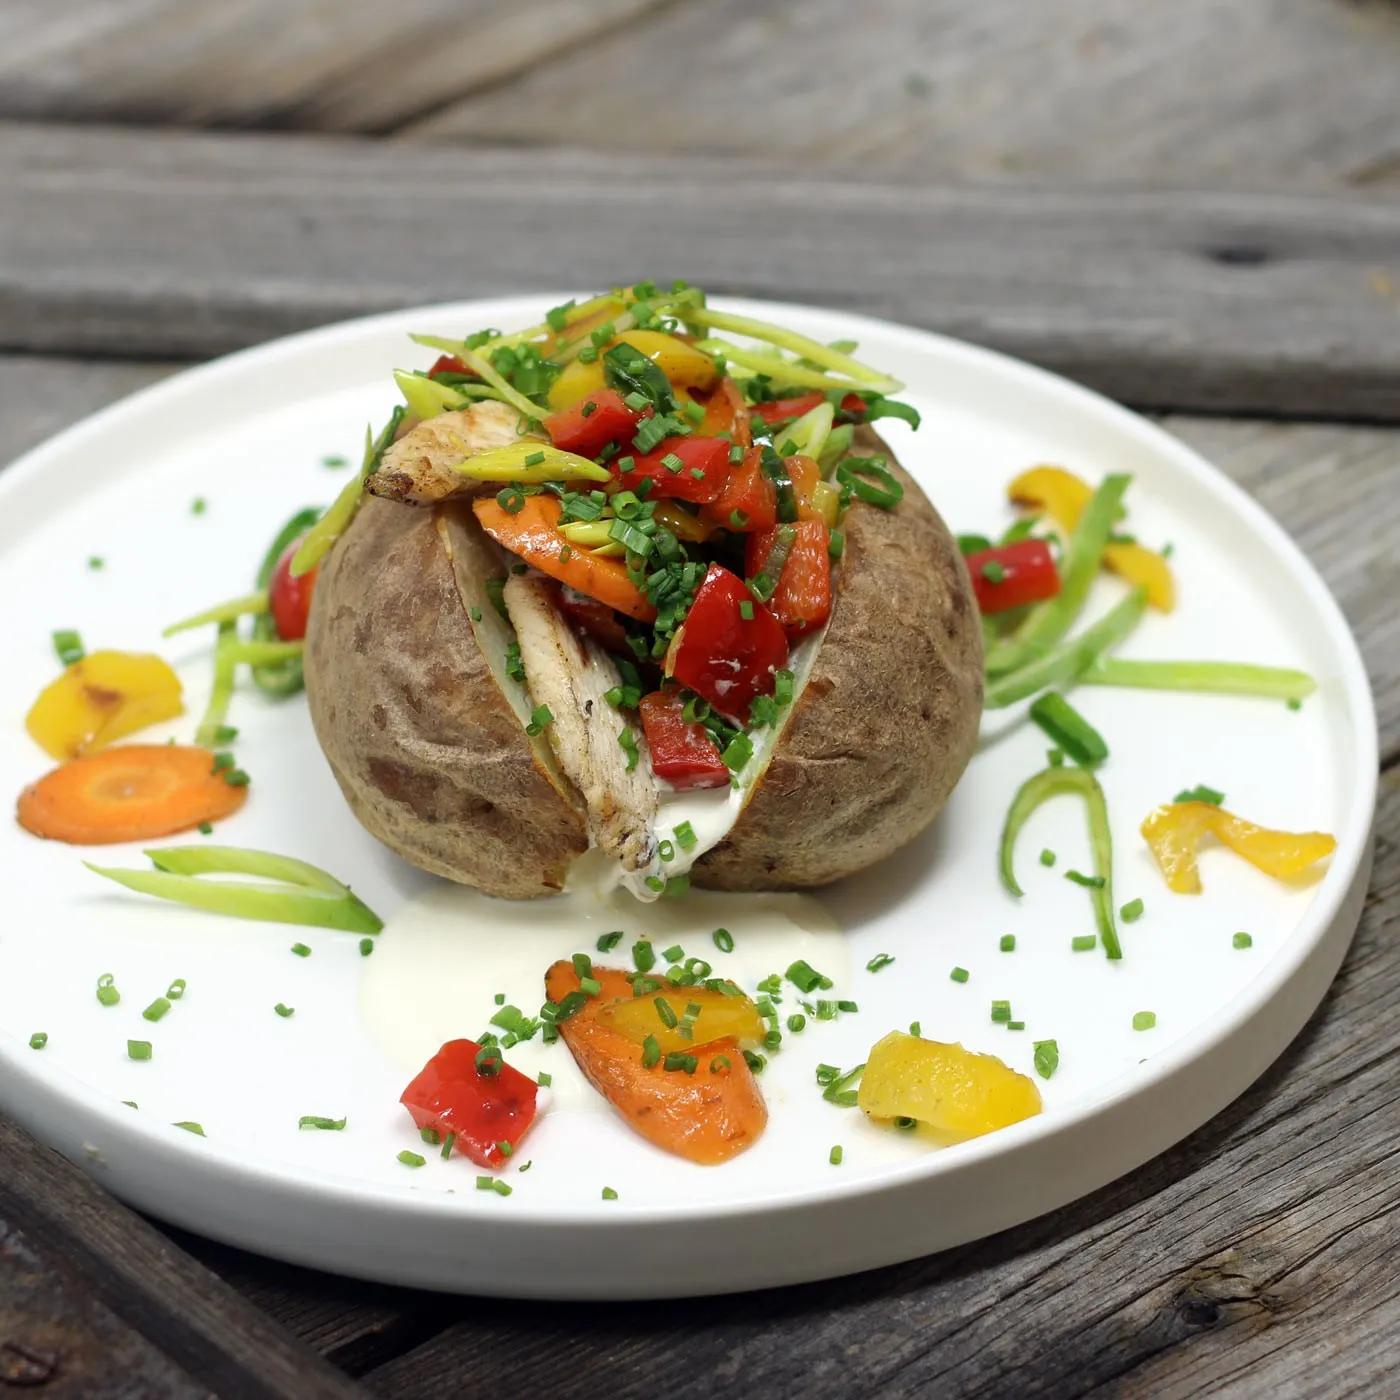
24,651 -> 185,759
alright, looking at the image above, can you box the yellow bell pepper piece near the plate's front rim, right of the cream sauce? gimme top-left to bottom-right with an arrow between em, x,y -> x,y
857,1030 -> 1040,1142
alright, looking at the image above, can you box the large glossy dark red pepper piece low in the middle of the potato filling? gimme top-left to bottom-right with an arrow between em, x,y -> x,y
666,564 -> 788,721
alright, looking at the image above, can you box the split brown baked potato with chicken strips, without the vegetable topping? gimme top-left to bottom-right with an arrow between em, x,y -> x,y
305,291 -> 983,897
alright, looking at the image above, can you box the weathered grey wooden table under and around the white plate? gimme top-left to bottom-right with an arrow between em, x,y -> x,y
0,0 -> 1400,1397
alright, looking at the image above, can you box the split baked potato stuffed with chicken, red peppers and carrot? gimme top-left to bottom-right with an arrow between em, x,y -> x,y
305,291 -> 983,899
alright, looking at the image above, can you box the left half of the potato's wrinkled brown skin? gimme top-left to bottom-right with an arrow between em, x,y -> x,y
305,498 -> 588,899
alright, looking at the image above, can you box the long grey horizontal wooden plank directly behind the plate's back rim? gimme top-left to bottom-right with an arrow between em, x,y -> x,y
0,126 -> 1400,419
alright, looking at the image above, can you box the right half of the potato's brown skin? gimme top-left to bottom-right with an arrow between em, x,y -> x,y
693,428 -> 983,890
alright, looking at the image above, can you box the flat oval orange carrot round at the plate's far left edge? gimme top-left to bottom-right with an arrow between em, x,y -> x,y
18,743 -> 248,846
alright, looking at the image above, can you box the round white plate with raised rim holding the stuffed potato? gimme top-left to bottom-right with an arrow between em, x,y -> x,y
0,297 -> 1376,1298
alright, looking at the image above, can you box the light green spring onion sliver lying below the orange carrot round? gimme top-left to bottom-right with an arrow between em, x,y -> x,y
84,846 -> 384,934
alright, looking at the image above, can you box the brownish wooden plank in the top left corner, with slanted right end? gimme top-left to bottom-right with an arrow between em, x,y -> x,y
0,0 -> 665,133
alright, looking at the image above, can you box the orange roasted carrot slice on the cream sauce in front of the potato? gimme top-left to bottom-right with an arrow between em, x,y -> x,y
545,962 -> 769,1166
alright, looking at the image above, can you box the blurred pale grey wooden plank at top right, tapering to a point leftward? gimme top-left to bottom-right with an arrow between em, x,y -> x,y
406,0 -> 1400,194
